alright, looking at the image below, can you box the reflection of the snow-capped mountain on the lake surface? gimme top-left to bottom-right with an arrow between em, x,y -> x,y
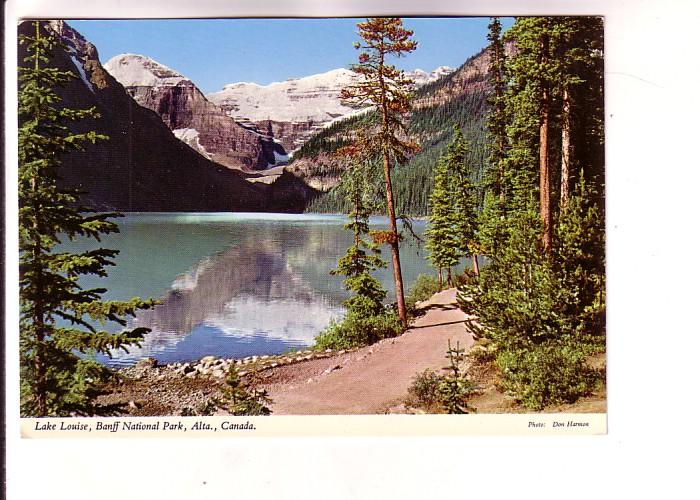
108,234 -> 342,364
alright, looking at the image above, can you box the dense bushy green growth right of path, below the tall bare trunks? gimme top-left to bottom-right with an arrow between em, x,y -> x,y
458,203 -> 605,409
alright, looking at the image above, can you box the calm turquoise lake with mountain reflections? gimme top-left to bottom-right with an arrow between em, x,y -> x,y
62,213 -> 434,367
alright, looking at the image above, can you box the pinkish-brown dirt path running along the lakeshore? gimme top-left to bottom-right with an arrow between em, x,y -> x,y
266,289 -> 474,415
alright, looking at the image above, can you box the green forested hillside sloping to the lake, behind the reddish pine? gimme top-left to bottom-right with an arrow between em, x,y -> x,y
300,47 -> 488,216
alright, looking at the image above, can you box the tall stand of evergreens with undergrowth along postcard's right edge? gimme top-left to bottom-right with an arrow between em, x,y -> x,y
452,17 -> 605,409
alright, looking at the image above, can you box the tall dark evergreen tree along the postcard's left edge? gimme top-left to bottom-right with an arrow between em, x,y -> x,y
18,22 -> 152,417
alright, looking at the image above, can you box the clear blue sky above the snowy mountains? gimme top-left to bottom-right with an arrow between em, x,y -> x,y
68,18 -> 512,93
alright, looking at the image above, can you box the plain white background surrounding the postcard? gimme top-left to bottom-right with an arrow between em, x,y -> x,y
5,0 -> 700,499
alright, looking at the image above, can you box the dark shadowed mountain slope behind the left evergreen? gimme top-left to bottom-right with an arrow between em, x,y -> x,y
19,21 -> 315,211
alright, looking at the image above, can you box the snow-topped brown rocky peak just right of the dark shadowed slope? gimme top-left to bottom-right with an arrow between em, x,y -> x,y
105,54 -> 286,171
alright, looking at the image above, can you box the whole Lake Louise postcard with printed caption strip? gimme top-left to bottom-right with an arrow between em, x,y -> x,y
8,4 -> 607,446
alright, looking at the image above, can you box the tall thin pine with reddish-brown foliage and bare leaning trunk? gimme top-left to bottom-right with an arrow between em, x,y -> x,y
341,17 -> 418,326
